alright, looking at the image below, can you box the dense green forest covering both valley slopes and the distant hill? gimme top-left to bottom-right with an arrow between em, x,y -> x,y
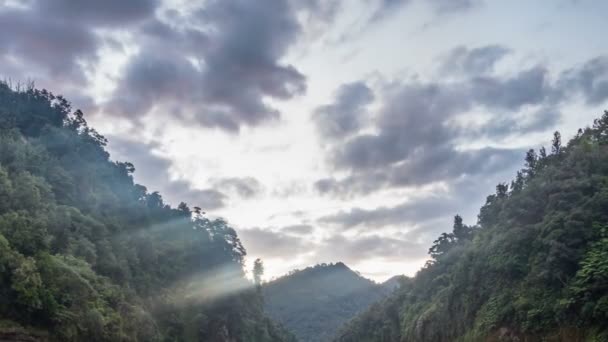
0,83 -> 608,342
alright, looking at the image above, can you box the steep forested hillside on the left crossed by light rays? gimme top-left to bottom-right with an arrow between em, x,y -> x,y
0,83 -> 292,342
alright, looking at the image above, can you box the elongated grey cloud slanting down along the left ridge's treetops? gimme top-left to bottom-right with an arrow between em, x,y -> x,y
108,137 -> 227,210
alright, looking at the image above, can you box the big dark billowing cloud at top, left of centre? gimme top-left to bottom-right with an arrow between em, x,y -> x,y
107,0 -> 342,132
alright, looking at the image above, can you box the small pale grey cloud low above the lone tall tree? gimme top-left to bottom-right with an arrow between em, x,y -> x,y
239,228 -> 310,258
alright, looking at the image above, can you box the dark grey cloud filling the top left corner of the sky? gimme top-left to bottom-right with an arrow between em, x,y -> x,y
0,0 -> 159,87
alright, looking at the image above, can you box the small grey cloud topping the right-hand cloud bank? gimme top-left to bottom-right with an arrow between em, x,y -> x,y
440,45 -> 510,75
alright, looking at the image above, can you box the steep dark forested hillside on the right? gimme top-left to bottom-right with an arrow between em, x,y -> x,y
337,112 -> 608,342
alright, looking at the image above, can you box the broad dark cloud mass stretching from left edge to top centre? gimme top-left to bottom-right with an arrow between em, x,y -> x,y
0,0 -> 339,132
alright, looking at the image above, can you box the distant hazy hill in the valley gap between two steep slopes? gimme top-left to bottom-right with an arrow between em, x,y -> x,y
263,262 -> 398,342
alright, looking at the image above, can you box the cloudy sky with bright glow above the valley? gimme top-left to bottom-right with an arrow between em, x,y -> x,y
0,0 -> 608,281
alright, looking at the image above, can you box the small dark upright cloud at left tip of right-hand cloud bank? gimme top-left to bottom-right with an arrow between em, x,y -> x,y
313,82 -> 374,139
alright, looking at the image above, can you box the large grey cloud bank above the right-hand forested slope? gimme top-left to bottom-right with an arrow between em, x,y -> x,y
314,45 -> 608,198
